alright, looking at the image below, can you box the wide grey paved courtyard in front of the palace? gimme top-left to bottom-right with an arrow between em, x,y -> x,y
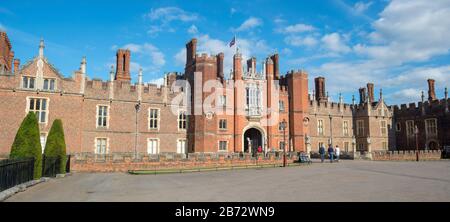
7,161 -> 450,202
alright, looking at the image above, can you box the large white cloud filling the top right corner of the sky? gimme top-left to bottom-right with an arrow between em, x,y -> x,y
356,0 -> 450,65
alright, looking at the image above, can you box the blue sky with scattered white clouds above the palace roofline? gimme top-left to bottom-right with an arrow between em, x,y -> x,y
0,0 -> 450,104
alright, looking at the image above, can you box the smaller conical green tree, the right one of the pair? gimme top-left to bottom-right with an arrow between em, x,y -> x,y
44,119 -> 67,173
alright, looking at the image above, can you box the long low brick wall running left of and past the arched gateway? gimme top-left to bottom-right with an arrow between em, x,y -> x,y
71,153 -> 298,172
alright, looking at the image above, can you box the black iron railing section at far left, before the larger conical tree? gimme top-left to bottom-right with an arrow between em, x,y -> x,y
0,158 -> 34,191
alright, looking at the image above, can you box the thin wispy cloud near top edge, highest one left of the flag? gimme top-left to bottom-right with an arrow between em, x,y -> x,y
146,7 -> 199,23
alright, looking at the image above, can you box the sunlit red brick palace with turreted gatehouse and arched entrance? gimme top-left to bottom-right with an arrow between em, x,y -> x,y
0,32 -> 448,155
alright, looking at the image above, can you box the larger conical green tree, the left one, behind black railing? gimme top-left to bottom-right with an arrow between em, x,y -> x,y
9,112 -> 42,179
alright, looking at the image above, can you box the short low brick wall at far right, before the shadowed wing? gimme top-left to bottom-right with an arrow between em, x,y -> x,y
372,150 -> 442,161
